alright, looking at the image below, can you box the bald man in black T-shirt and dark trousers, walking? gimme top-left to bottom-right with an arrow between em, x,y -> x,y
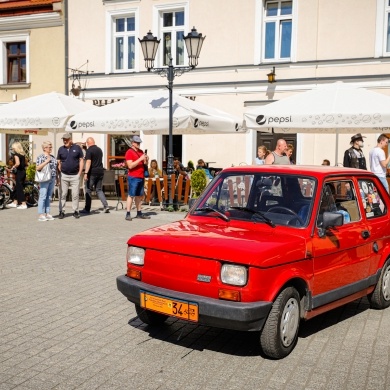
80,137 -> 110,214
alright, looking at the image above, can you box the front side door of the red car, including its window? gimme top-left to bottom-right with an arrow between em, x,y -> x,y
312,178 -> 371,307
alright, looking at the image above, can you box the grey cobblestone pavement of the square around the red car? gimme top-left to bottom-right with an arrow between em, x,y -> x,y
0,201 -> 390,390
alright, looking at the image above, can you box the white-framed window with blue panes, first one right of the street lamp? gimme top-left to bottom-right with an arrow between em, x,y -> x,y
262,0 -> 290,60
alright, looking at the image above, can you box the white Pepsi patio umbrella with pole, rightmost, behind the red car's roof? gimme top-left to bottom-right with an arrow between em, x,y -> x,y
244,82 -> 390,161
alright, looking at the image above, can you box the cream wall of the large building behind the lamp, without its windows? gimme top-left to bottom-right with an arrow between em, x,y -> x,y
65,0 -> 390,171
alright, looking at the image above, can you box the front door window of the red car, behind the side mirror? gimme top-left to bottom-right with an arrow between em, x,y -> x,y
317,180 -> 360,226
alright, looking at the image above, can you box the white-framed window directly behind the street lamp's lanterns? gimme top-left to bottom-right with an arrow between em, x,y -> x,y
160,9 -> 185,66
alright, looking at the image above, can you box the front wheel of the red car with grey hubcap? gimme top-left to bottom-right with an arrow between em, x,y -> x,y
260,287 -> 300,359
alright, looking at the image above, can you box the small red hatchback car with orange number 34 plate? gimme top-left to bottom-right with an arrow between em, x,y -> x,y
117,165 -> 390,359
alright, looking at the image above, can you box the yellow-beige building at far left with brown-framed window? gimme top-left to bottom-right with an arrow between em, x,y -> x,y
0,0 -> 66,162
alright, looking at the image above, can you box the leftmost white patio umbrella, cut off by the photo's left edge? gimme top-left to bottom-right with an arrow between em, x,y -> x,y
0,92 -> 91,134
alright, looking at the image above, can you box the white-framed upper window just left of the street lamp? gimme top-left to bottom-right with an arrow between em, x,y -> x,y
112,15 -> 135,71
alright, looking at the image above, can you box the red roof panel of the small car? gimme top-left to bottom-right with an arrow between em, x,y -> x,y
223,165 -> 375,178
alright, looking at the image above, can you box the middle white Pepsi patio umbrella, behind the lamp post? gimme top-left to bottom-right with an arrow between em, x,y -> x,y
66,90 -> 246,134
